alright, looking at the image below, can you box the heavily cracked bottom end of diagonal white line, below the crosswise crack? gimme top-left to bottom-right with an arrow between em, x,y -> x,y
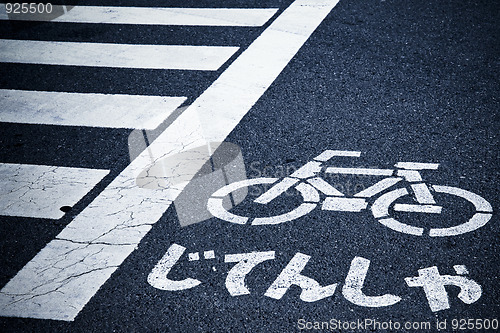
0,239 -> 136,320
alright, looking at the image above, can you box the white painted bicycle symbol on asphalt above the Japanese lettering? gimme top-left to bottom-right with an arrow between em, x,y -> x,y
207,150 -> 493,237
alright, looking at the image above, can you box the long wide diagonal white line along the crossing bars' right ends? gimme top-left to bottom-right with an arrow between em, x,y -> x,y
0,0 -> 338,321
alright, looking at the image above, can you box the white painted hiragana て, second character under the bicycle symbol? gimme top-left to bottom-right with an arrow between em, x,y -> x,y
224,251 -> 274,296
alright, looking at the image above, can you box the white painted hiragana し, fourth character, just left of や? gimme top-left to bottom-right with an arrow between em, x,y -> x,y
342,257 -> 401,308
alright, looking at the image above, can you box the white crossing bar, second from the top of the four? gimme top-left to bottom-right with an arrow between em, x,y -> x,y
0,39 -> 238,71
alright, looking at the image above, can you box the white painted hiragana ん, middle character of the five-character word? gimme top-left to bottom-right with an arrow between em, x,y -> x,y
264,253 -> 337,302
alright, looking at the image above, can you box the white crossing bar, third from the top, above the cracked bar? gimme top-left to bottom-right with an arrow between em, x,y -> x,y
0,89 -> 186,129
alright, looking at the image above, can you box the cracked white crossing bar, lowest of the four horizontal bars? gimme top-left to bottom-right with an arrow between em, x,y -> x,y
0,163 -> 109,219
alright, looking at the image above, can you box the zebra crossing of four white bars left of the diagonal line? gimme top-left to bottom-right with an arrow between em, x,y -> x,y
0,4 -> 277,218
